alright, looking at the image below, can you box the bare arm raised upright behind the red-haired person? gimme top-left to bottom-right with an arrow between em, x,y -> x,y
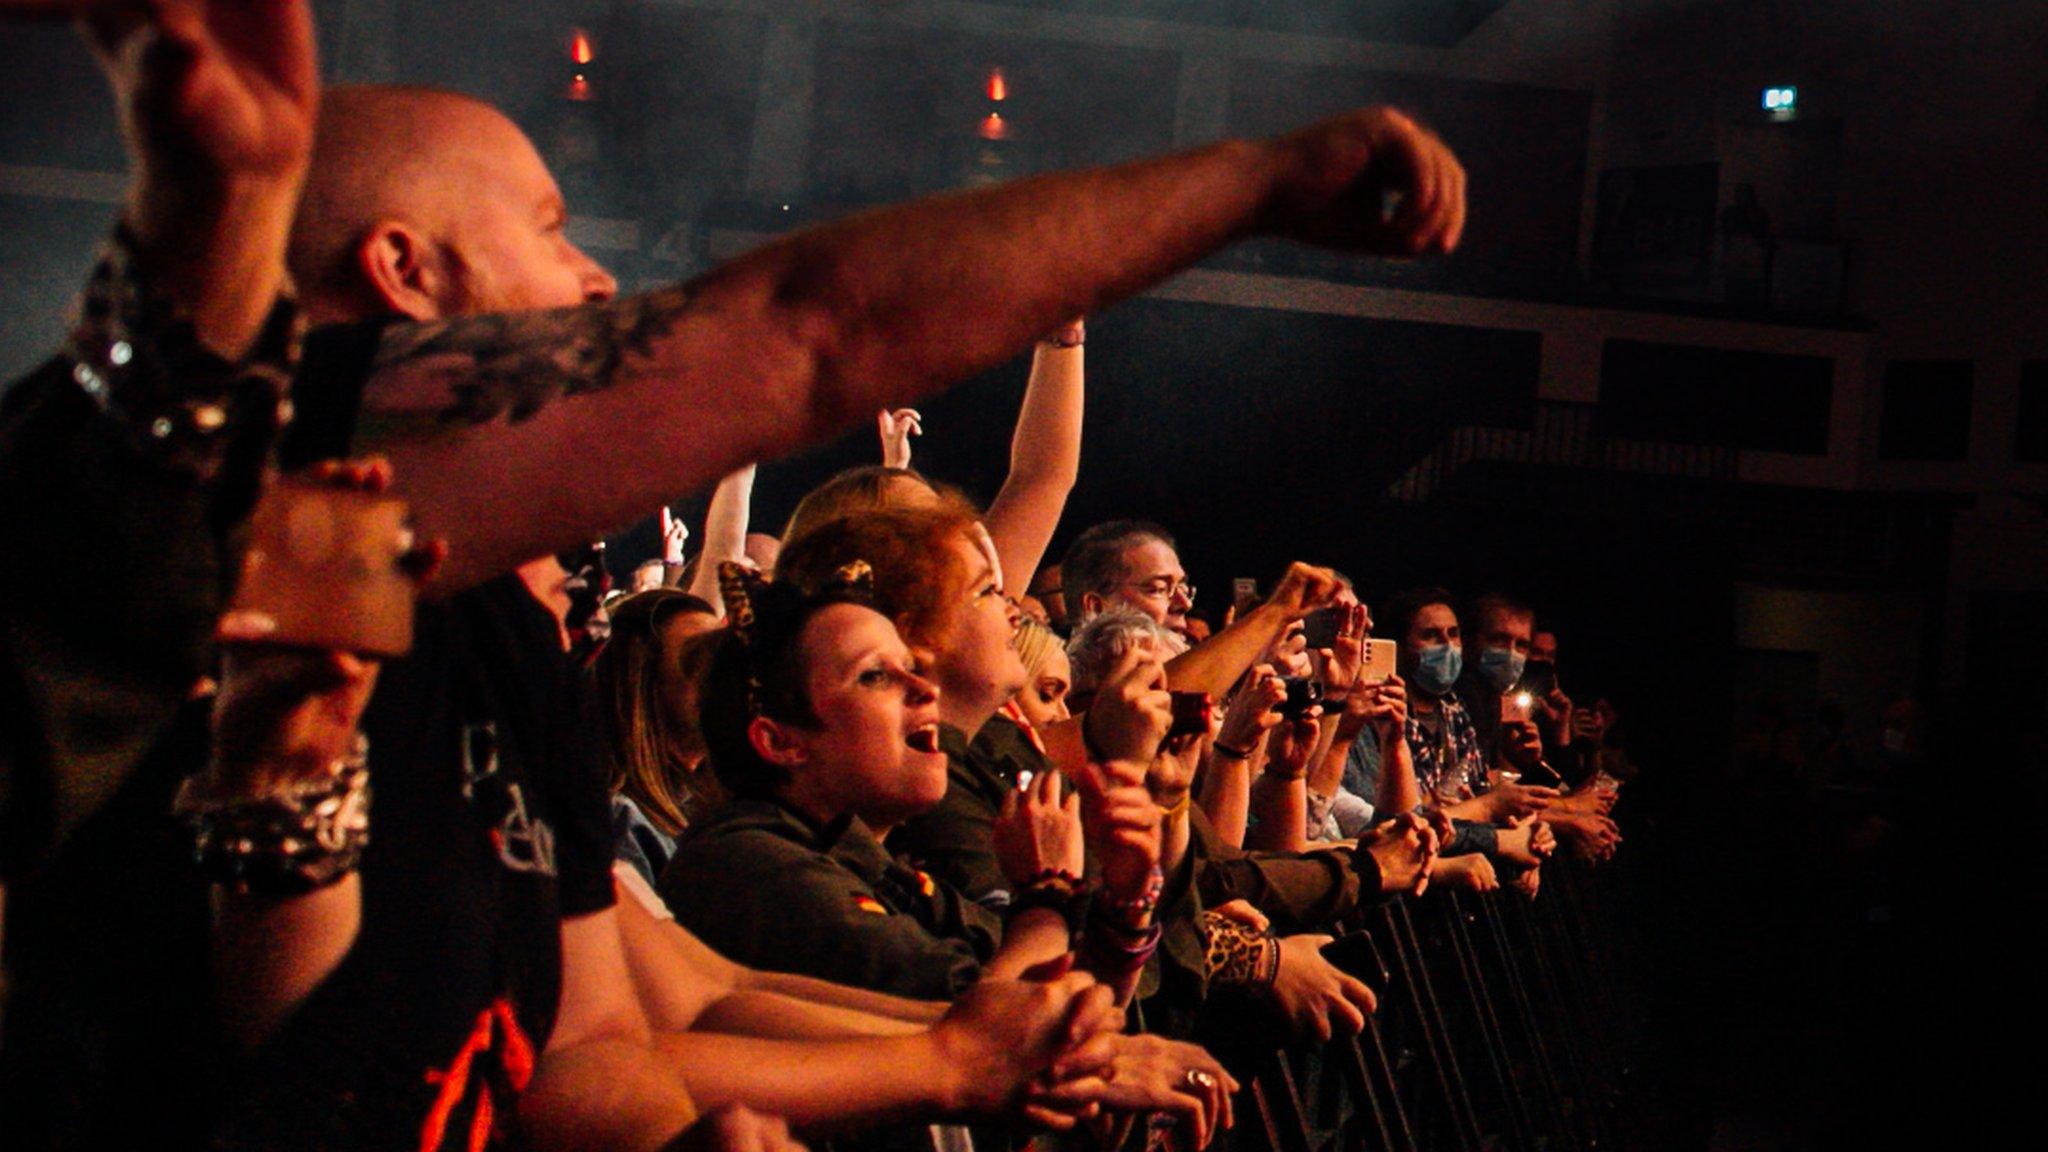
987,320 -> 1087,596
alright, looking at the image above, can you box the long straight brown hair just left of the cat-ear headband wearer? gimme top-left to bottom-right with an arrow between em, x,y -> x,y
594,588 -> 719,836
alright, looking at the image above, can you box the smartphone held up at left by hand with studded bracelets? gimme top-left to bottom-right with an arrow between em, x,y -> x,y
227,478 -> 416,658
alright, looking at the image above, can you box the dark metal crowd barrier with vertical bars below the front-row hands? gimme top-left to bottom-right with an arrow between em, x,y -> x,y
1229,859 -> 1642,1152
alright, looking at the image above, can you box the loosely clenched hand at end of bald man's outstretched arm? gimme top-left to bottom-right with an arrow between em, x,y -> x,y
1270,109 -> 1464,256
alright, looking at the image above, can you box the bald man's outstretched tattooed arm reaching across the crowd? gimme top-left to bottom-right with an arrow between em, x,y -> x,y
352,109 -> 1464,588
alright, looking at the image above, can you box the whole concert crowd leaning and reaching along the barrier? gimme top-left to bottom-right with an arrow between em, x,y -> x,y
0,0 -> 1632,1152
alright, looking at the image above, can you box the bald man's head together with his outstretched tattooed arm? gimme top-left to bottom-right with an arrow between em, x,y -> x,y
291,88 -> 1464,586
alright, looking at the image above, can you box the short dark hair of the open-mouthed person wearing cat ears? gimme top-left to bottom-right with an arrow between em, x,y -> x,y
696,569 -> 872,797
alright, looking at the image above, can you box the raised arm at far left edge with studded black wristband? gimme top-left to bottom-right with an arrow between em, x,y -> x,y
0,0 -> 317,875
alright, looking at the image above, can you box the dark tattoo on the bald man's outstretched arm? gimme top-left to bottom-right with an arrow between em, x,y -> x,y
373,285 -> 690,426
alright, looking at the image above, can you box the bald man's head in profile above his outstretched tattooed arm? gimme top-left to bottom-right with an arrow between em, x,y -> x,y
289,86 -> 614,322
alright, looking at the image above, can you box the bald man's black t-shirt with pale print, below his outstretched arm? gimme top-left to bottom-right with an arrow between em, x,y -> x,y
223,576 -> 612,1148
